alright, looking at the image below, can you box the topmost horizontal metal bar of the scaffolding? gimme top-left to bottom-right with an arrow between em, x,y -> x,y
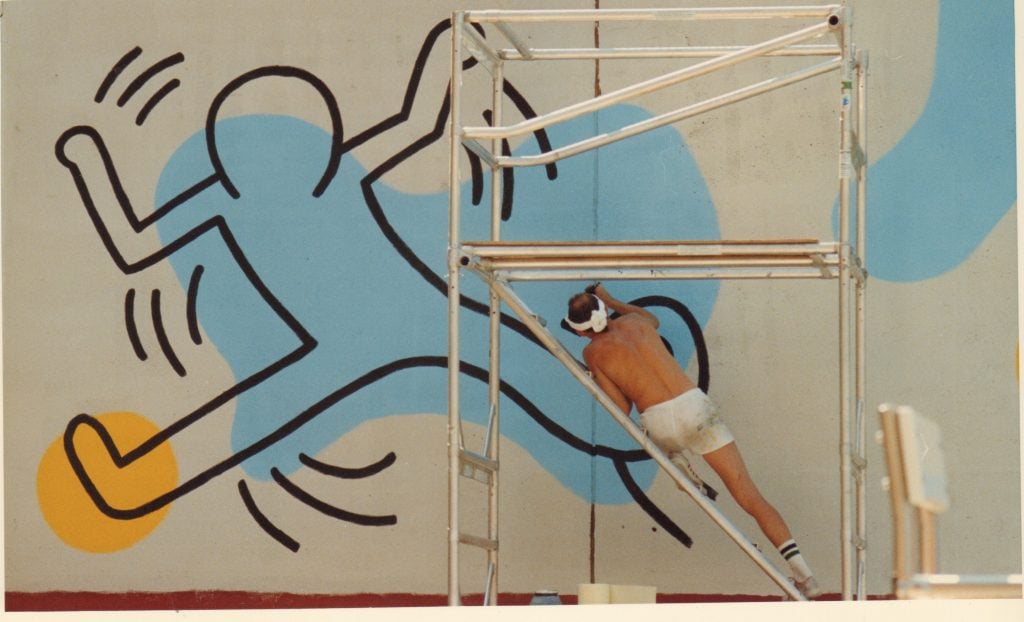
466,4 -> 841,24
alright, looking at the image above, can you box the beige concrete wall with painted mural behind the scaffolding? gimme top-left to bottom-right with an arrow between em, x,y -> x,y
0,0 -> 1021,597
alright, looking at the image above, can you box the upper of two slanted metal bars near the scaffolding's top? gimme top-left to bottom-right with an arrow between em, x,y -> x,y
463,22 -> 833,139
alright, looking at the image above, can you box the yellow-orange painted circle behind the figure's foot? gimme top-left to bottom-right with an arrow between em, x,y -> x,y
36,412 -> 178,552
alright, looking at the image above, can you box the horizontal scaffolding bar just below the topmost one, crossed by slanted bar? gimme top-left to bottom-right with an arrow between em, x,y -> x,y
495,45 -> 842,60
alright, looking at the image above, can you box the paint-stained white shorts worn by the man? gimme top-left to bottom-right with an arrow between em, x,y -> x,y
640,388 -> 734,456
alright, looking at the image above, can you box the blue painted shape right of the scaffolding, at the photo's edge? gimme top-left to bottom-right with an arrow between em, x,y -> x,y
833,0 -> 1017,282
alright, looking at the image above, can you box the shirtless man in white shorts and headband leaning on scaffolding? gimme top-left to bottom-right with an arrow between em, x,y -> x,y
565,283 -> 821,598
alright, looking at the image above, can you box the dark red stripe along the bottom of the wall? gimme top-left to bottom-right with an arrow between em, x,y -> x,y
4,590 -> 891,612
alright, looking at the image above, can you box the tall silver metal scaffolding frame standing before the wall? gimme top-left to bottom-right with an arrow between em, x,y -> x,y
447,1 -> 867,605
